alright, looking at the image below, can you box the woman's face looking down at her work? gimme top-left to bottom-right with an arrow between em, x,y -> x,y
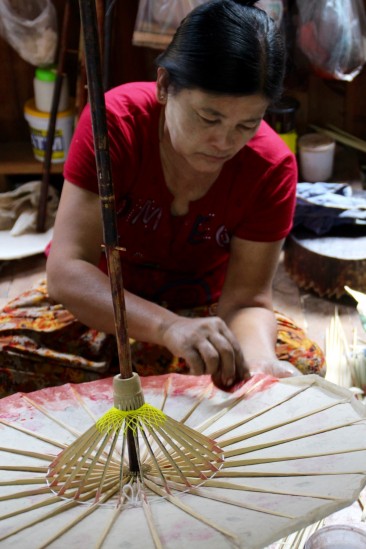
164,89 -> 268,173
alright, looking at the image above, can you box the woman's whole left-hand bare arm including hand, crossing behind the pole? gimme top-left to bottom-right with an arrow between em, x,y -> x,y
47,181 -> 248,385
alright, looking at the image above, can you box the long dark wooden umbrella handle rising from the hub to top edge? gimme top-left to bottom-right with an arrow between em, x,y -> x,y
79,0 -> 132,379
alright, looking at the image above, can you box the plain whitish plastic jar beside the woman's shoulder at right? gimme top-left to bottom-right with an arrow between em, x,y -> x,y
298,133 -> 335,183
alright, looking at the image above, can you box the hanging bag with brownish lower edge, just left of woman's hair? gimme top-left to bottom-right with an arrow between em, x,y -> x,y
132,0 -> 206,49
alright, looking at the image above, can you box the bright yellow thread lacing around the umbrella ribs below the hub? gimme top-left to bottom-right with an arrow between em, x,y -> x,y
96,403 -> 166,434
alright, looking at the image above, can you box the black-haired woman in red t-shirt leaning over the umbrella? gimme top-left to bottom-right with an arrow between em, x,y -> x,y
0,0 -> 323,394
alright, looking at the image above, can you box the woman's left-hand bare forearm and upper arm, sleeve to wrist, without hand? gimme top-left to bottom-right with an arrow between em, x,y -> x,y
47,181 -> 175,334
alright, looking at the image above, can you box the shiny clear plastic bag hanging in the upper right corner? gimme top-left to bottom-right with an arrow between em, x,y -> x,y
297,0 -> 366,81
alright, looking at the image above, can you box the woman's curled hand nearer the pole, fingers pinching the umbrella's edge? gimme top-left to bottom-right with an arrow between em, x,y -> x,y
163,317 -> 250,388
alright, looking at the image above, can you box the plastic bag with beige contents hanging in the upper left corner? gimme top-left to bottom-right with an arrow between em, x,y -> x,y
0,0 -> 57,66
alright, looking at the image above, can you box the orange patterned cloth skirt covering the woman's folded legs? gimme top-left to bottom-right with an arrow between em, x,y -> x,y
0,282 -> 325,396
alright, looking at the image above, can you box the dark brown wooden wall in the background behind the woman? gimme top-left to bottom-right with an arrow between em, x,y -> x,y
0,0 -> 366,149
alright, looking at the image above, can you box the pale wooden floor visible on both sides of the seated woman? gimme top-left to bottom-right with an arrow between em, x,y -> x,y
0,249 -> 362,360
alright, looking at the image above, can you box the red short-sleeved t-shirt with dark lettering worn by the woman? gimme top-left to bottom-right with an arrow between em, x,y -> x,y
64,82 -> 297,309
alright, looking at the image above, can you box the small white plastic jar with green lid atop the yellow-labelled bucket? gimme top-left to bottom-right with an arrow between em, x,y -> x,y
33,65 -> 69,112
